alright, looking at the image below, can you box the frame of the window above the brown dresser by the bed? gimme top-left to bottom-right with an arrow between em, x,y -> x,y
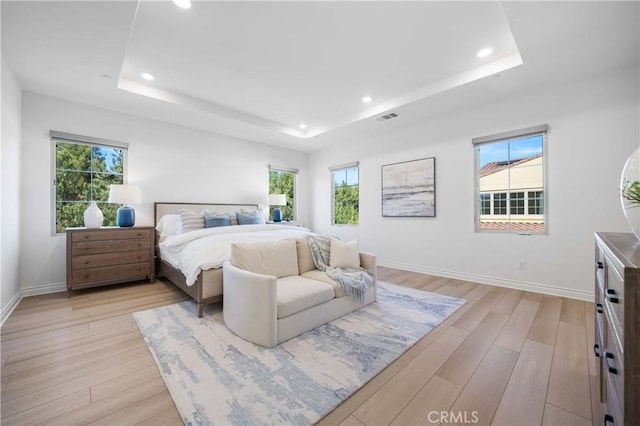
49,130 -> 129,237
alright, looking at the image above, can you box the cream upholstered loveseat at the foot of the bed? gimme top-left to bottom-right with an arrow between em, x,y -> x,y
222,239 -> 377,347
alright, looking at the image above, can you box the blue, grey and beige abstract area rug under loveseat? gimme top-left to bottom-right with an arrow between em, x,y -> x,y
133,282 -> 465,425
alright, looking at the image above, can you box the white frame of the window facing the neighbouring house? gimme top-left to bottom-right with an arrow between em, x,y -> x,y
472,124 -> 549,235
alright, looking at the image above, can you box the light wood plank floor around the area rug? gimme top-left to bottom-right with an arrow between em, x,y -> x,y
0,268 -> 602,425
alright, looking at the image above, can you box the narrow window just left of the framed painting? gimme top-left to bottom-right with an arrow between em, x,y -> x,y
329,163 -> 360,225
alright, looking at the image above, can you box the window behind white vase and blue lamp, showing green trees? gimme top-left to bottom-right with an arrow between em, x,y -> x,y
51,131 -> 127,233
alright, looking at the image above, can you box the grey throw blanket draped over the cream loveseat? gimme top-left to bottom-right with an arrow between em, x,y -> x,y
306,235 -> 374,302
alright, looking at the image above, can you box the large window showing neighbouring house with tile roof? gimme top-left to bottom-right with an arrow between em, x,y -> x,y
473,125 -> 548,234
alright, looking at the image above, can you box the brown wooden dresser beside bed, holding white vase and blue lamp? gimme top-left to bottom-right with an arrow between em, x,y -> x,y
66,226 -> 155,296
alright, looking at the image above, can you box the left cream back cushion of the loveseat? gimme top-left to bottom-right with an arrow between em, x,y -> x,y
231,239 -> 298,278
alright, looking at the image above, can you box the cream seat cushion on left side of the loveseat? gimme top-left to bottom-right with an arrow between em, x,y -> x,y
277,276 -> 334,318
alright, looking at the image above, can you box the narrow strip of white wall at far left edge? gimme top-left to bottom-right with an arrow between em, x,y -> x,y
0,56 -> 22,323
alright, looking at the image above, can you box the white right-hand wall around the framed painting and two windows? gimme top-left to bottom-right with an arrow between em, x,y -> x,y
309,68 -> 640,299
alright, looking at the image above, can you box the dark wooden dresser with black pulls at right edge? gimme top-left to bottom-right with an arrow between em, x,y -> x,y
594,232 -> 640,425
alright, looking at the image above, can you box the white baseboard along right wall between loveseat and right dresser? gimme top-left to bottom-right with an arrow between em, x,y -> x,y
377,259 -> 595,302
